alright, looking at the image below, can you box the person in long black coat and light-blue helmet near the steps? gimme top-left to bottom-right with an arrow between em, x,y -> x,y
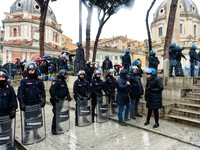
144,68 -> 163,128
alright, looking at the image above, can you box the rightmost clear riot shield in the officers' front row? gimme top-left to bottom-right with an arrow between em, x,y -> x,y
106,92 -> 118,117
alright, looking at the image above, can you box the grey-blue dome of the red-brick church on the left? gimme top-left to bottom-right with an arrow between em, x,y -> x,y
10,0 -> 57,22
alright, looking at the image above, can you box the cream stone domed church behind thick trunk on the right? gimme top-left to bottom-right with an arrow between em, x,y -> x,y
151,0 -> 200,69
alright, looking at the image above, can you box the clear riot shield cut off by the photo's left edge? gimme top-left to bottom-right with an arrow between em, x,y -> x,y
0,116 -> 15,150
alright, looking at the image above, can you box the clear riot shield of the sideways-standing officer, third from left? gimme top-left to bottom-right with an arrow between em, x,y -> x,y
56,100 -> 70,134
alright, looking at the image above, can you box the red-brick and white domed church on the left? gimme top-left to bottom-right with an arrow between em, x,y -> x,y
2,0 -> 62,64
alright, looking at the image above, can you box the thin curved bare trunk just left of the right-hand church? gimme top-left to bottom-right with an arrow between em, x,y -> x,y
146,0 -> 156,51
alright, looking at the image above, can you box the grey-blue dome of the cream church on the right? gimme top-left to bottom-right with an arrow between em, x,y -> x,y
154,0 -> 199,19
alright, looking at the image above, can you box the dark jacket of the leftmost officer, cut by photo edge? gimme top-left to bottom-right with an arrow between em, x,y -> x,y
0,84 -> 18,116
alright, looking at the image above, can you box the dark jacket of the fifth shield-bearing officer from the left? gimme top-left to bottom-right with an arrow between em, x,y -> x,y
90,77 -> 104,96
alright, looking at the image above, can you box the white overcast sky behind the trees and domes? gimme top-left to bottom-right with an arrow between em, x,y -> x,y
0,0 -> 200,43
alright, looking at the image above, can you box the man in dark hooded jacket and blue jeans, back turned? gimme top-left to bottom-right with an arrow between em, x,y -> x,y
117,69 -> 130,126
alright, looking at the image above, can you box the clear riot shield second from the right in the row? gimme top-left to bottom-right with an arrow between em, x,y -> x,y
97,96 -> 108,123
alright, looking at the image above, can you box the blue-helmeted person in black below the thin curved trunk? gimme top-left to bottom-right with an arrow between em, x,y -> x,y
148,50 -> 160,71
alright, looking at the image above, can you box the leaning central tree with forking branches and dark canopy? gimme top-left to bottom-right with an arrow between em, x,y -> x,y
90,0 -> 134,62
